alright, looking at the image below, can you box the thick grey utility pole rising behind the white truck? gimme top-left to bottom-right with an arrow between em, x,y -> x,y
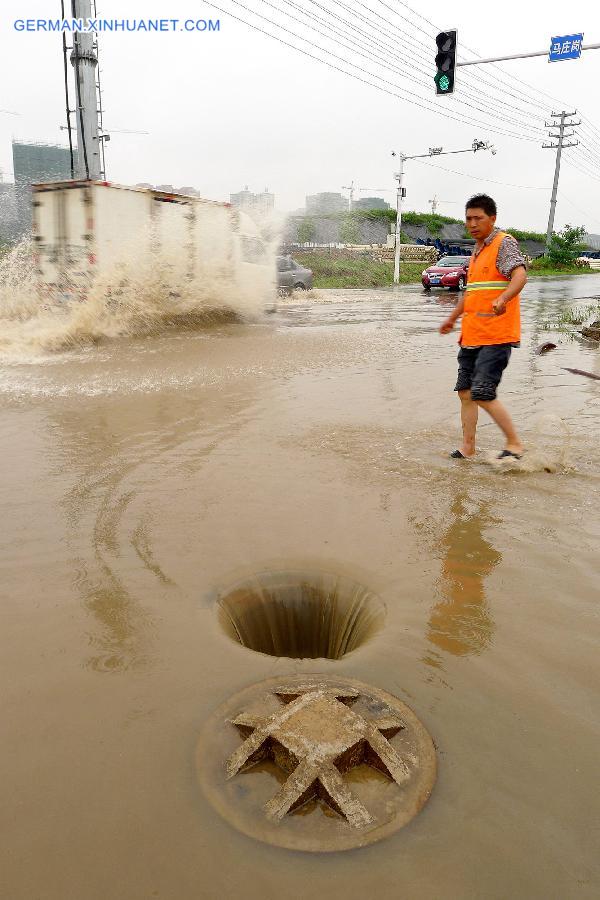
71,0 -> 102,181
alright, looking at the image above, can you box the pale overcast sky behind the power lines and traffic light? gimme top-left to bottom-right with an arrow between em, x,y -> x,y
0,0 -> 600,233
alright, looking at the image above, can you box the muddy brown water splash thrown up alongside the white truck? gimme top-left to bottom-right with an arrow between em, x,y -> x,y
0,230 -> 275,364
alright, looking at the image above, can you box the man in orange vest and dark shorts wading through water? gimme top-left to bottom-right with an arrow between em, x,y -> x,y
440,194 -> 527,459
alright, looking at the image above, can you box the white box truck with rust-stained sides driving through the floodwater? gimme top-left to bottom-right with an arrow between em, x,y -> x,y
32,181 -> 277,315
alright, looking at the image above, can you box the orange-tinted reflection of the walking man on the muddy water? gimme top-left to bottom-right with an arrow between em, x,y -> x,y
427,493 -> 502,664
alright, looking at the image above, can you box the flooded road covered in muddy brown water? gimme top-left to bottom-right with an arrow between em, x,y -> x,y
0,275 -> 600,900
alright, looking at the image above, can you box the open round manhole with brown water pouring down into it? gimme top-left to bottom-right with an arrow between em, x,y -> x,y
219,571 -> 385,659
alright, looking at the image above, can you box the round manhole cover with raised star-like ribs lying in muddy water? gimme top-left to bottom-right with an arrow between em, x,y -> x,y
196,675 -> 436,851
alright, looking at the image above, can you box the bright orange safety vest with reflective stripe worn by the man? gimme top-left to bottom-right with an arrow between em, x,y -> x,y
459,231 -> 521,347
